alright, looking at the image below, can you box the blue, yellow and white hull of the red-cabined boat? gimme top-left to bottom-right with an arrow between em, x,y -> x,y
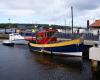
29,39 -> 87,56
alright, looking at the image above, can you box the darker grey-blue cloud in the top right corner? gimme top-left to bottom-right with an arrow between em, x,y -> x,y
66,0 -> 100,11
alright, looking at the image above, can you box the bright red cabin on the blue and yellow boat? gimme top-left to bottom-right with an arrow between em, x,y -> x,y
35,29 -> 57,44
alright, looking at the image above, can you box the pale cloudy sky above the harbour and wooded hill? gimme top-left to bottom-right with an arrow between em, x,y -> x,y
0,0 -> 100,27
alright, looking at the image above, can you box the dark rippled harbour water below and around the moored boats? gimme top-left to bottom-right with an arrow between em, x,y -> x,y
0,44 -> 100,80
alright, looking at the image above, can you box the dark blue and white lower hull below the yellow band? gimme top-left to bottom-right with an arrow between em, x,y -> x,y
29,44 -> 87,56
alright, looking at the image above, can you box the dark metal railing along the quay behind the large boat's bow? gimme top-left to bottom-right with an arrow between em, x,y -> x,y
55,32 -> 99,41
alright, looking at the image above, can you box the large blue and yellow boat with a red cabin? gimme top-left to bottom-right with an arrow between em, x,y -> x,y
28,29 -> 87,56
